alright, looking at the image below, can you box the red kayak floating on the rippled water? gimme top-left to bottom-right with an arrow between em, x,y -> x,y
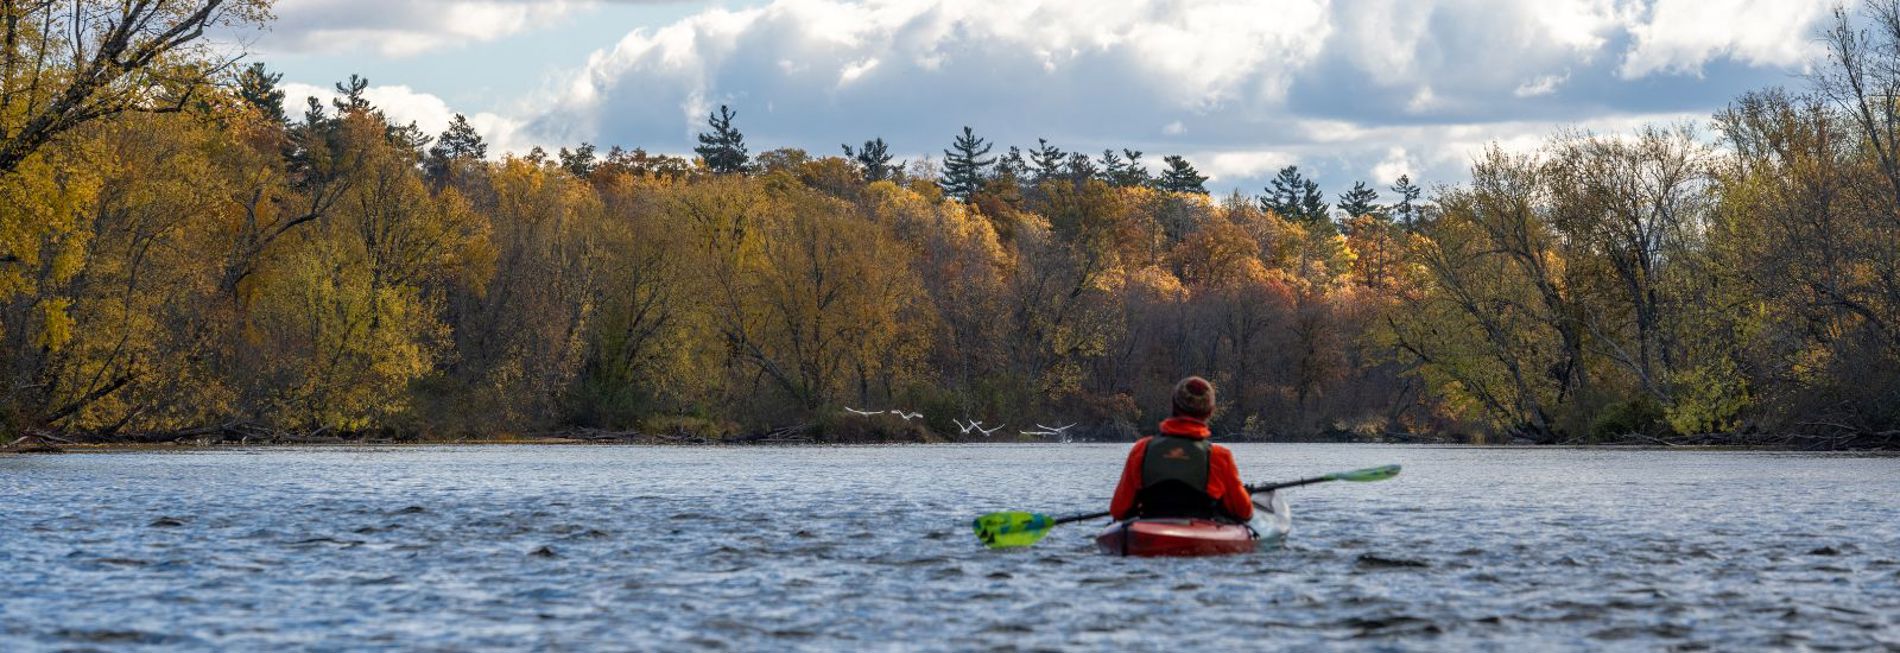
1094,494 -> 1292,556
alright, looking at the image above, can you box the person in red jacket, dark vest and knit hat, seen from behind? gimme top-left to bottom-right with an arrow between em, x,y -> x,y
1108,376 -> 1254,522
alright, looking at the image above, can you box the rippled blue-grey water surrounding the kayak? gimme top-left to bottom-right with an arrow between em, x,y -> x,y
0,444 -> 1900,651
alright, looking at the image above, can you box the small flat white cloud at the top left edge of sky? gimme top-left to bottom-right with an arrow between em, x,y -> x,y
257,0 -> 595,57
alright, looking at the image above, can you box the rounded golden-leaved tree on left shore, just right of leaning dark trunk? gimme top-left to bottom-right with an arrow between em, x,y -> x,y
247,104 -> 486,429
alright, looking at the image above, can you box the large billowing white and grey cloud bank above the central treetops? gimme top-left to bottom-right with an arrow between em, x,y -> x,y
471,0 -> 1822,188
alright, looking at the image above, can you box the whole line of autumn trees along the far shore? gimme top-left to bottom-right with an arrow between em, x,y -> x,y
0,0 -> 1900,446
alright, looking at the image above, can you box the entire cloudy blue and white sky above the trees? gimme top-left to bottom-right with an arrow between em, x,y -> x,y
224,0 -> 1834,196
